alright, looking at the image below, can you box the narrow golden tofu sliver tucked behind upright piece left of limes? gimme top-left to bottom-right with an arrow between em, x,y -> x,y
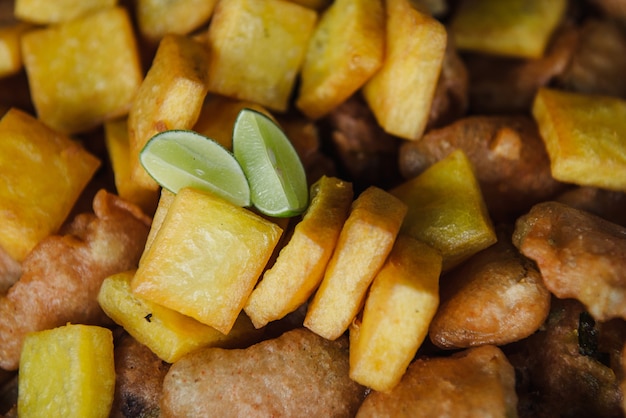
104,117 -> 159,215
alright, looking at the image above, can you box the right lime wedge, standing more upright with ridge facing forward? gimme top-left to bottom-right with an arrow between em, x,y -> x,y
233,108 -> 309,217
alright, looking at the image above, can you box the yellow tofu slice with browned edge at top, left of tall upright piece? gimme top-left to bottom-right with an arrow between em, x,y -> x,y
296,0 -> 385,119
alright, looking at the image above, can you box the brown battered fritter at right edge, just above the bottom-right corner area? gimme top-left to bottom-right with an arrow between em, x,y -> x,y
513,202 -> 626,321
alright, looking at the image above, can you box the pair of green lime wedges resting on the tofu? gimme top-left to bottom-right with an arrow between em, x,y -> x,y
139,108 -> 309,217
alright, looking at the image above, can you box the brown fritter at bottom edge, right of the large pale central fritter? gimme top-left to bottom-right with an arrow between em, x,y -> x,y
356,345 -> 517,418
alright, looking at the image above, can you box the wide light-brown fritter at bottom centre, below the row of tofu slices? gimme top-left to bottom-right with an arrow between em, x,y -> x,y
161,328 -> 365,418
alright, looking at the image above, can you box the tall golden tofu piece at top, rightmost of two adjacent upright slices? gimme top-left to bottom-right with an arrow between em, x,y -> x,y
363,0 -> 447,140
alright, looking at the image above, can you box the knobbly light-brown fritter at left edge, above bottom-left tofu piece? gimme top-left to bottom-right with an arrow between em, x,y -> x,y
0,190 -> 150,370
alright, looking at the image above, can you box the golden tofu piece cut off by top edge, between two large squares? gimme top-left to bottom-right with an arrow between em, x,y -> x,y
135,0 -> 217,42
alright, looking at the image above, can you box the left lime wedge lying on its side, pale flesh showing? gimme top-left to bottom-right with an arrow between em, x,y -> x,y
139,130 -> 250,206
